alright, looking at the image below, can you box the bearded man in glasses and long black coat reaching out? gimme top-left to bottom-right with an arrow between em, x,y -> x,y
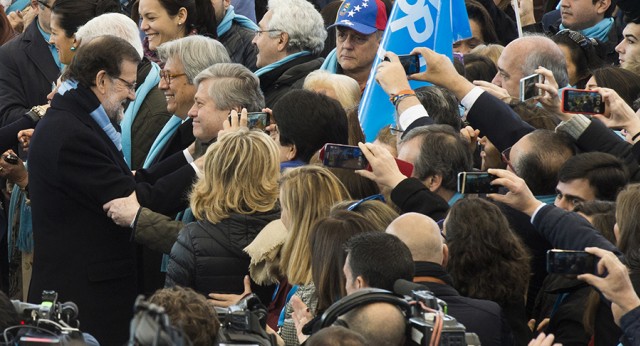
27,36 -> 195,345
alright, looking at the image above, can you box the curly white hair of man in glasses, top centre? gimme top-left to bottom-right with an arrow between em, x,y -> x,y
267,0 -> 327,54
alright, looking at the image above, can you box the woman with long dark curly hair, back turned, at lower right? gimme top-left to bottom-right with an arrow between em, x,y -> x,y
443,198 -> 532,345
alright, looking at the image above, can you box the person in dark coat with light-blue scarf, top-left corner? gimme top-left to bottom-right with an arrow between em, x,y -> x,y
0,0 -> 61,126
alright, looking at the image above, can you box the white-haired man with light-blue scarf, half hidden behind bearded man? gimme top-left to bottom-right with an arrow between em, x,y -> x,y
76,13 -> 171,170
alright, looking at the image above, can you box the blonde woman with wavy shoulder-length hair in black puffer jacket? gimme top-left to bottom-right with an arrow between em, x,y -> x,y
165,128 -> 280,298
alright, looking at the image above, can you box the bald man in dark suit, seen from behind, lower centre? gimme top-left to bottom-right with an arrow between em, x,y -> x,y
386,213 -> 513,345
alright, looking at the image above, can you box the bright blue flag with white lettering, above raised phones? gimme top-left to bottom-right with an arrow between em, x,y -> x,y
358,0 -> 471,141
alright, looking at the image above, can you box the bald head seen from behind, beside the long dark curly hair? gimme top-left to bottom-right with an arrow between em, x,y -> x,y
386,213 -> 443,264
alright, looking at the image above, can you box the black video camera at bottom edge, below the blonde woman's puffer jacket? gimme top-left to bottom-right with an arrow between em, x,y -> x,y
216,293 -> 276,346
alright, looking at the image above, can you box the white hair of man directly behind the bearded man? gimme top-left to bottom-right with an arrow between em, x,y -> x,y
76,13 -> 144,59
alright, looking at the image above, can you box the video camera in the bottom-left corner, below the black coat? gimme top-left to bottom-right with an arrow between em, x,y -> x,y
2,291 -> 85,345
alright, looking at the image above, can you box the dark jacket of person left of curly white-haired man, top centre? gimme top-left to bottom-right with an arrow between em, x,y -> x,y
218,22 -> 258,71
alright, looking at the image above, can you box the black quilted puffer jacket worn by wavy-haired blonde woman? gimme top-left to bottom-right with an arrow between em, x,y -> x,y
165,210 -> 280,294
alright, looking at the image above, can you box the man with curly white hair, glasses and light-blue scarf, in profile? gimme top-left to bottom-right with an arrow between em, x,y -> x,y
252,0 -> 327,108
